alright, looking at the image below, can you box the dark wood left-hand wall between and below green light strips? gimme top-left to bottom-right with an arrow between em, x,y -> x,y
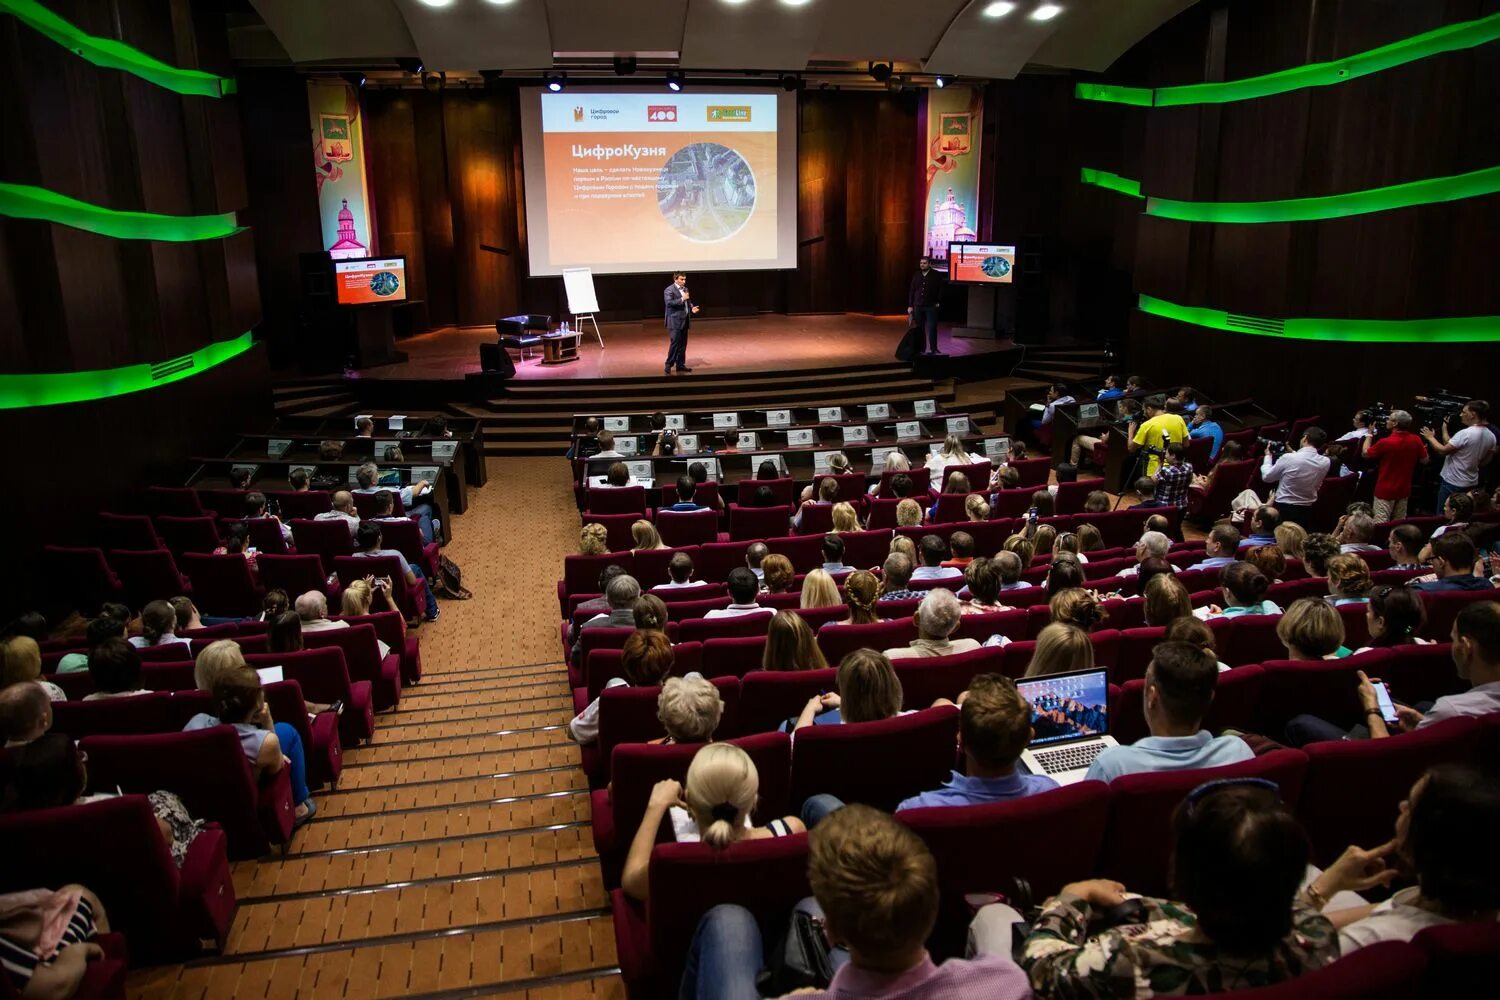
0,0 -> 267,607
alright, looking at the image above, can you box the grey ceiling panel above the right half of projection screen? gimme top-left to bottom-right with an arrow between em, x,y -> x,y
681,0 -> 834,70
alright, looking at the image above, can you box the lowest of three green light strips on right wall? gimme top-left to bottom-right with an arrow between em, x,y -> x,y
1137,295 -> 1500,343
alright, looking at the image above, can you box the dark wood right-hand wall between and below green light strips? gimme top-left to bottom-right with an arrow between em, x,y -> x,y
1086,0 -> 1500,424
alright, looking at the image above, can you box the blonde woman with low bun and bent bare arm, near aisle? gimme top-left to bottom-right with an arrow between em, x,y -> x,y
620,744 -> 807,903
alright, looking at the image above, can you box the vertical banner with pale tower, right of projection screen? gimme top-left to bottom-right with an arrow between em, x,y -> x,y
918,87 -> 984,268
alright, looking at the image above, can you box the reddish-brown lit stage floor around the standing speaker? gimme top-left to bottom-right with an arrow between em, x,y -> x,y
362,313 -> 1011,379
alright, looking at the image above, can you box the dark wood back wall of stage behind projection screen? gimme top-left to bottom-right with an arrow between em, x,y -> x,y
242,72 -> 920,347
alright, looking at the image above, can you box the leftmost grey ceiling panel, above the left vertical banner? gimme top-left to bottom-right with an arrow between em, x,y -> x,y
252,0 -> 417,63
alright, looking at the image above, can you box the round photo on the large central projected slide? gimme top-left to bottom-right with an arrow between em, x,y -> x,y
657,142 -> 756,243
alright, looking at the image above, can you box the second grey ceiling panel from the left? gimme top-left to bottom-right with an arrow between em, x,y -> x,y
387,0 -> 552,70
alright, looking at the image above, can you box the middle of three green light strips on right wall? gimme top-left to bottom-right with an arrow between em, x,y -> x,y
1082,166 -> 1500,223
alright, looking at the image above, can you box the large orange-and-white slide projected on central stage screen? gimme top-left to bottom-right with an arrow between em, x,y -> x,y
521,87 -> 797,277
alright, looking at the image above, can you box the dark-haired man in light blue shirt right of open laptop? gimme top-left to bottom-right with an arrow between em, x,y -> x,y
1088,642 -> 1256,781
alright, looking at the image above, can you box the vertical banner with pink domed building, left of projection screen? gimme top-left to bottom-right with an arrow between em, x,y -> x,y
308,79 -> 375,259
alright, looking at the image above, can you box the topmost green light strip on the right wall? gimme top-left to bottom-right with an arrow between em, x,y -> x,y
1074,13 -> 1500,108
